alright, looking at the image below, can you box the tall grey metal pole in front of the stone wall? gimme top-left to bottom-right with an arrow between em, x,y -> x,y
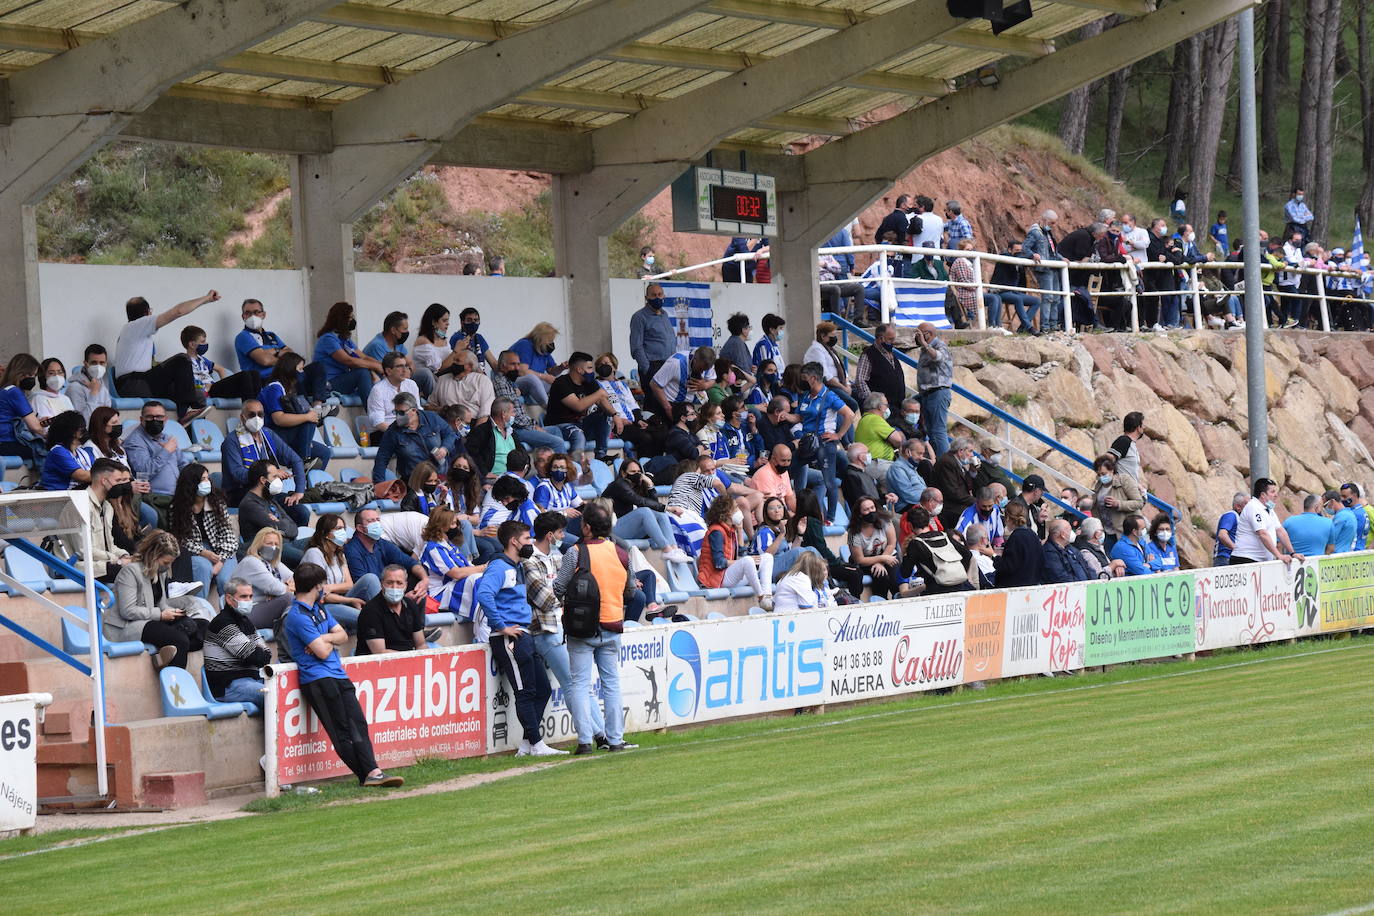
1238,7 -> 1270,483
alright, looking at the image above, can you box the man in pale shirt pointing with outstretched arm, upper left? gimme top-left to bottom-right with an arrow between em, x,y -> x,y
114,290 -> 220,423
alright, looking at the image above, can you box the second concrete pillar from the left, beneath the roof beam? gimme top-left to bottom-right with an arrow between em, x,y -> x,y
290,155 -> 357,330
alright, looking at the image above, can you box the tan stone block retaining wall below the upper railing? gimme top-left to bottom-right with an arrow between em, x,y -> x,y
908,331 -> 1374,566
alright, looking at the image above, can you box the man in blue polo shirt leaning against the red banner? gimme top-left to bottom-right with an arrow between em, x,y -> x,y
282,563 -> 405,787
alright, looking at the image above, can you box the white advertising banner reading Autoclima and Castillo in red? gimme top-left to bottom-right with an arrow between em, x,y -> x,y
818,595 -> 966,702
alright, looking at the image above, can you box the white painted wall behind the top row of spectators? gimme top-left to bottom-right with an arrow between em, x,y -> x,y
32,264 -> 780,381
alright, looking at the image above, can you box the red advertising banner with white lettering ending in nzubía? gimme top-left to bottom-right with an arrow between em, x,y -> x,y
265,645 -> 488,794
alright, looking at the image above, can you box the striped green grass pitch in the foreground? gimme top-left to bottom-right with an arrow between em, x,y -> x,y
0,639 -> 1374,913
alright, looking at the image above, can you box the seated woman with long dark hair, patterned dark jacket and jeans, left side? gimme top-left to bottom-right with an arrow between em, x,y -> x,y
168,463 -> 239,599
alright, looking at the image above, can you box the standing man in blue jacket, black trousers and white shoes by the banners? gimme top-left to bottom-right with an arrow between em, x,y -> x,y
477,519 -> 572,757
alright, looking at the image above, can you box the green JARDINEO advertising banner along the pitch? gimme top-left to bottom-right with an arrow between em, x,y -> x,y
1084,573 -> 1197,665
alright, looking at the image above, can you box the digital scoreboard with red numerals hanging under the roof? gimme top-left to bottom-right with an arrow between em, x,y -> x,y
673,166 -> 778,236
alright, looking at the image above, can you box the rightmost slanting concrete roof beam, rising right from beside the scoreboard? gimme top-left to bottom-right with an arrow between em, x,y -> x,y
796,0 -> 1256,243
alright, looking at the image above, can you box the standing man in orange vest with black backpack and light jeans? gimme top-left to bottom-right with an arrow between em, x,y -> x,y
554,505 -> 637,754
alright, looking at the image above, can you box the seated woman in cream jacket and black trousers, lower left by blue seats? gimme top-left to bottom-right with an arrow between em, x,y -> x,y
102,529 -> 213,669
